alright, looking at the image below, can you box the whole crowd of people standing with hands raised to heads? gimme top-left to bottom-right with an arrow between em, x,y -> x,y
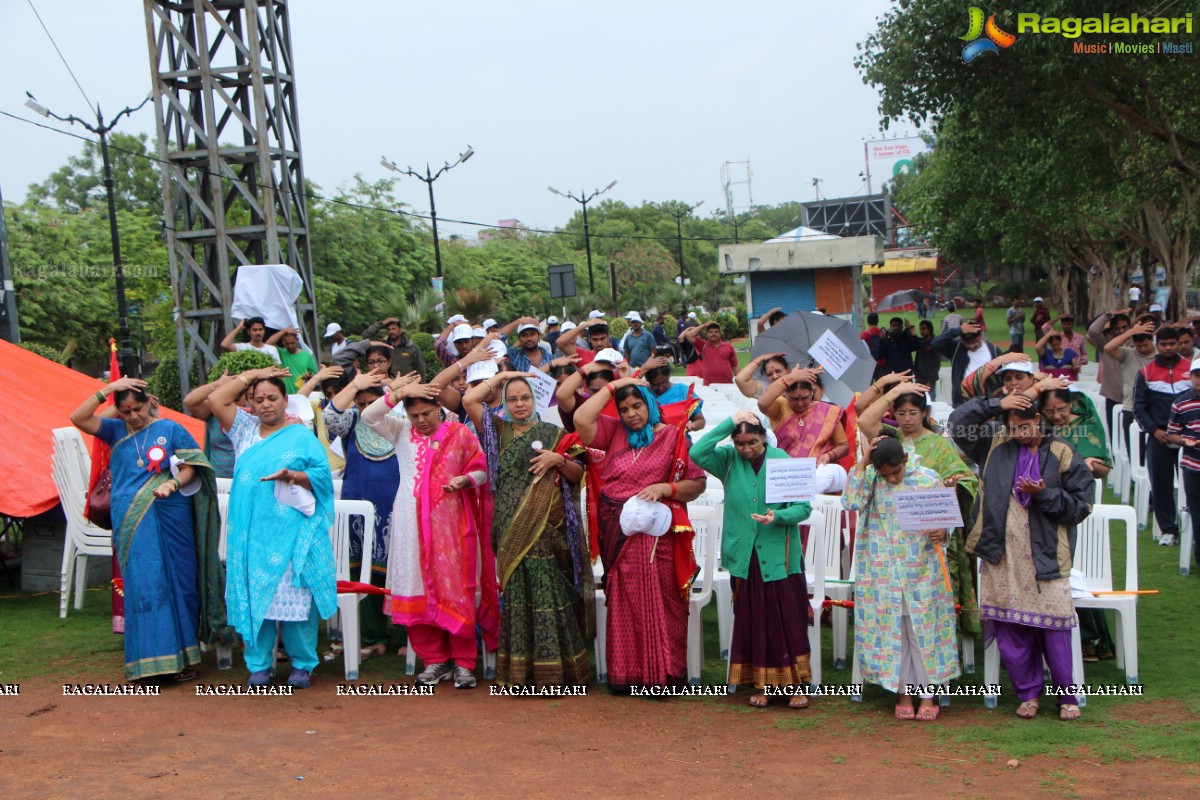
65,299 -> 1180,721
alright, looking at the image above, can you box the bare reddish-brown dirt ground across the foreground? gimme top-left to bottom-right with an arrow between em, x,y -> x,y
0,667 -> 1196,800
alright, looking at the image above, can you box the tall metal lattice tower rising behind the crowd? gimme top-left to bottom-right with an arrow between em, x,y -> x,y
144,0 -> 320,393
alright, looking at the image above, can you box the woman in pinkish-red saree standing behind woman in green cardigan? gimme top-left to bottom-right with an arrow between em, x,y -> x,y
758,369 -> 850,467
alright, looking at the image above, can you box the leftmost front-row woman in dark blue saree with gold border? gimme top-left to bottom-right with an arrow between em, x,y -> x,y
71,378 -> 232,681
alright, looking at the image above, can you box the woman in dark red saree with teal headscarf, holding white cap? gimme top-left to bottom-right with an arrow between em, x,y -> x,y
575,378 -> 704,692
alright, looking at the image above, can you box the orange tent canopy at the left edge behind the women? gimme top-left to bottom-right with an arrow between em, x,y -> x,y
0,341 -> 204,517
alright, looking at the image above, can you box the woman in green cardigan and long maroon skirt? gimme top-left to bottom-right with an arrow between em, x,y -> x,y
689,411 -> 820,709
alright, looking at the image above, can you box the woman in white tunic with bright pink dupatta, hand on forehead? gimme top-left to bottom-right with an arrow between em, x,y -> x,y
362,384 -> 499,688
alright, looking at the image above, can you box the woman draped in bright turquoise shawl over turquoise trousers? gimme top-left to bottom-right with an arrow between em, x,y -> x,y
209,367 -> 337,688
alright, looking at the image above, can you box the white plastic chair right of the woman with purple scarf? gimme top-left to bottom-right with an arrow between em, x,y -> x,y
1074,505 -> 1138,684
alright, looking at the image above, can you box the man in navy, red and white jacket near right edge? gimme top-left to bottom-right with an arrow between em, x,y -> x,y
1133,326 -> 1192,546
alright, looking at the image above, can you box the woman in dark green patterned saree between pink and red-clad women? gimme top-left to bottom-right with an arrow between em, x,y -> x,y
463,372 -> 595,686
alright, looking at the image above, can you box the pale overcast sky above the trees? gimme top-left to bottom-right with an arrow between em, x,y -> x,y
0,0 -> 908,236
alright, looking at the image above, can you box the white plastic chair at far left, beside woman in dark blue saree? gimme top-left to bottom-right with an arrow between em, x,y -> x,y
50,428 -> 115,619
